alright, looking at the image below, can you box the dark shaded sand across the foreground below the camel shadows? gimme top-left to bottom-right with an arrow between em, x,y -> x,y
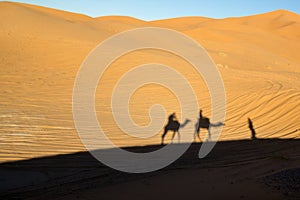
0,139 -> 300,199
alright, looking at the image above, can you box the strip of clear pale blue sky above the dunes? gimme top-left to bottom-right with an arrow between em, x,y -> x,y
2,0 -> 300,20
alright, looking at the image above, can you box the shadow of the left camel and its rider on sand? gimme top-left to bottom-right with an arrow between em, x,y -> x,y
161,114 -> 191,145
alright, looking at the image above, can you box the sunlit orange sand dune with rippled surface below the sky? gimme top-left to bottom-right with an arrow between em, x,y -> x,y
0,2 -> 300,162
